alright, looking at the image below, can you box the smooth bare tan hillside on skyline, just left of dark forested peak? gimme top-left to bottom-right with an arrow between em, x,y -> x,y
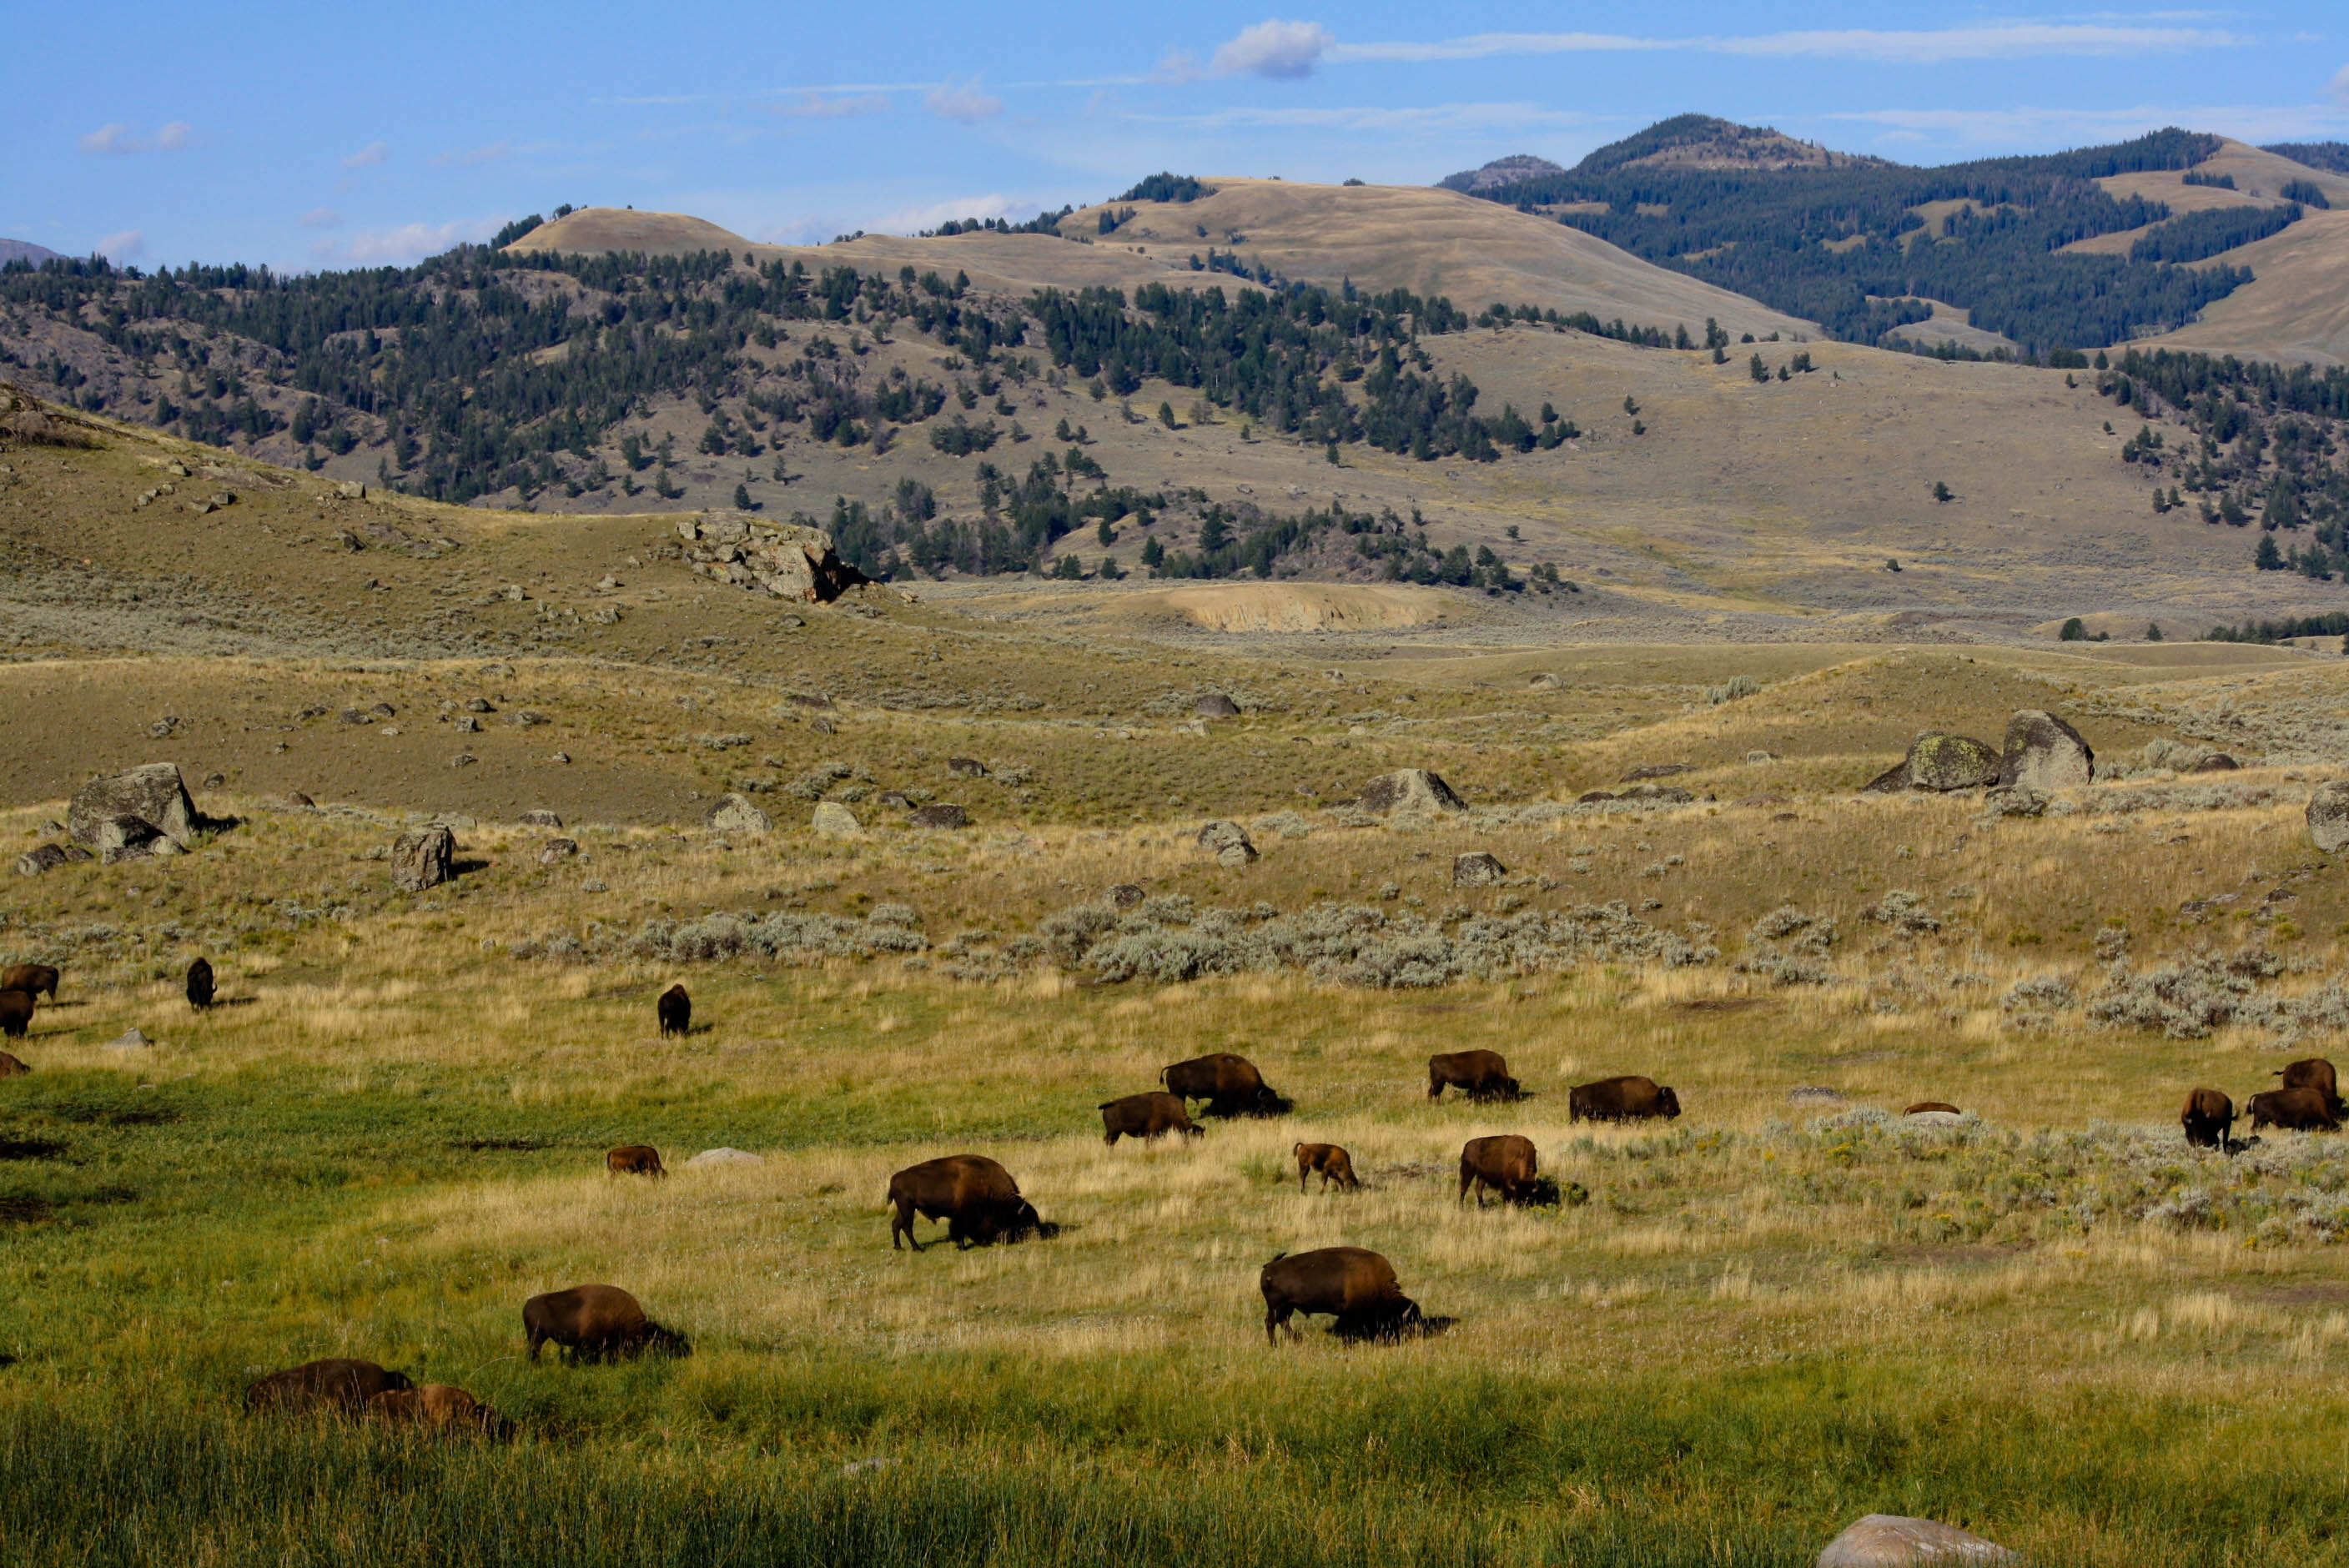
1062,178 -> 1818,338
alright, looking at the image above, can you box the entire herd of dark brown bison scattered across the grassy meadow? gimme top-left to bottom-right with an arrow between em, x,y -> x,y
0,957 -> 2342,1436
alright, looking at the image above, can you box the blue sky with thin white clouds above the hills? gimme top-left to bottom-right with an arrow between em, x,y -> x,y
13,0 -> 2349,268
